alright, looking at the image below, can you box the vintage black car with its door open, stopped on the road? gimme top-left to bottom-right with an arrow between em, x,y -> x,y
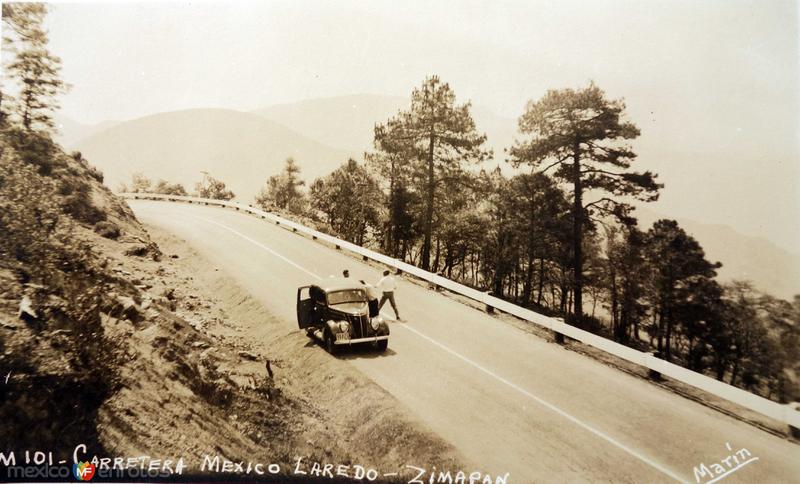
297,278 -> 389,354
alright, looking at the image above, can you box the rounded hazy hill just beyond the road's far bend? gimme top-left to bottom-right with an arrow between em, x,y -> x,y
75,109 -> 358,203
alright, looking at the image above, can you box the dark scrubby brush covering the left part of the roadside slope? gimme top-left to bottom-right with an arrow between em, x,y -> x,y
0,129 -> 286,464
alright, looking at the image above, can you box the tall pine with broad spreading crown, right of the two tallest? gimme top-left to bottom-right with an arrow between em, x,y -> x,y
510,84 -> 662,319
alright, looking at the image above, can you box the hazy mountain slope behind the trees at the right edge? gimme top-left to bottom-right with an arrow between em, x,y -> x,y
636,207 -> 800,300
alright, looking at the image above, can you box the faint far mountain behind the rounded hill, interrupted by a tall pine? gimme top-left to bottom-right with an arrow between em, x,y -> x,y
253,94 -> 516,164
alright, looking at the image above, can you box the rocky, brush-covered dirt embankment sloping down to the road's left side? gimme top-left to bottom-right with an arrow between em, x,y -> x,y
0,131 -> 459,482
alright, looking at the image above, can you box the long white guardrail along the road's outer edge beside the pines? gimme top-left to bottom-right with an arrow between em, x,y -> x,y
118,193 -> 800,428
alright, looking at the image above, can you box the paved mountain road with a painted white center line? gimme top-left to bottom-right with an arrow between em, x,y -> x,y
130,201 -> 800,482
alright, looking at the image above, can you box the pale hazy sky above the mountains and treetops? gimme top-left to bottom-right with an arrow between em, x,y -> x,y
32,0 -> 800,252
